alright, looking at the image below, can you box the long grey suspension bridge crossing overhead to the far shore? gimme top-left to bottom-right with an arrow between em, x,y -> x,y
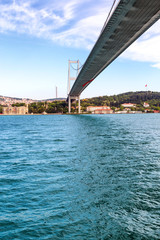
67,0 -> 160,113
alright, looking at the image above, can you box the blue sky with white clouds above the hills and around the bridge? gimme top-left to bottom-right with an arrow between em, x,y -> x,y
0,0 -> 160,99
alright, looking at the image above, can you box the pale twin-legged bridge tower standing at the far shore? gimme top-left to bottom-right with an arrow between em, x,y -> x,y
68,60 -> 80,113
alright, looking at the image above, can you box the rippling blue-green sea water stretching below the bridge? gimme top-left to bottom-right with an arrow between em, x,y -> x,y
0,114 -> 160,240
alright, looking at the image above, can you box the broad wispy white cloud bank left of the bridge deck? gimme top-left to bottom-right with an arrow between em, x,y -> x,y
0,0 -> 111,48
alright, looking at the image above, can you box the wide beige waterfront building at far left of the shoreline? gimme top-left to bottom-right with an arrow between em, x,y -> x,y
3,106 -> 28,115
